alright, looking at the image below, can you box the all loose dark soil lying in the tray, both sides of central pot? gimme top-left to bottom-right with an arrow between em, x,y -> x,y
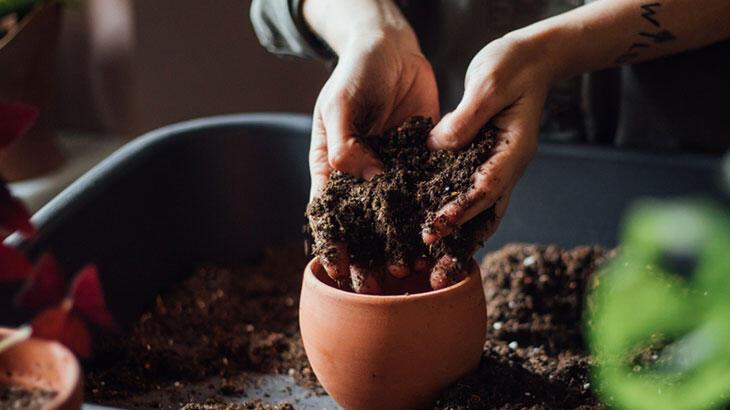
86,245 -> 610,410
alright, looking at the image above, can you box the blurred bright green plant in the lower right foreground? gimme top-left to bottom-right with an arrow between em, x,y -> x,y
585,200 -> 730,410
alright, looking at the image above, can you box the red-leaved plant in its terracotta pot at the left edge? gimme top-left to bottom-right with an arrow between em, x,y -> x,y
0,100 -> 115,409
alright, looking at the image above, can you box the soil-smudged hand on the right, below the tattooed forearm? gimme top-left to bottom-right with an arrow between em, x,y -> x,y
422,35 -> 557,250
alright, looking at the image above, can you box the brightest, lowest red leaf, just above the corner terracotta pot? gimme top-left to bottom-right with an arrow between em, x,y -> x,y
31,300 -> 91,357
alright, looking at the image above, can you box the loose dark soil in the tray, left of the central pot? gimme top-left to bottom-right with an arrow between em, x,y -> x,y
86,245 -> 323,408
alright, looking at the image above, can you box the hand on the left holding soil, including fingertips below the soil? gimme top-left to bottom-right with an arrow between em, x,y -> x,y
309,27 -> 439,293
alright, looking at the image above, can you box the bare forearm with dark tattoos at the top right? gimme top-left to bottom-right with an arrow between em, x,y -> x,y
508,0 -> 730,78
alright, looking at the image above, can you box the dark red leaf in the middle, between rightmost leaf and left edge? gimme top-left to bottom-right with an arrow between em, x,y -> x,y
15,253 -> 66,309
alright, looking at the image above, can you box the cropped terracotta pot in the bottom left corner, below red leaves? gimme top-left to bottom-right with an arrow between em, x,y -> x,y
0,328 -> 83,410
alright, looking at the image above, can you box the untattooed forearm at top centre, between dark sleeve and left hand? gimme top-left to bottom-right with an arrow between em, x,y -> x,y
302,0 -> 418,55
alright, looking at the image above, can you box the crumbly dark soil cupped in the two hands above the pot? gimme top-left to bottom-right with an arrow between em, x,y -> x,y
307,117 -> 497,288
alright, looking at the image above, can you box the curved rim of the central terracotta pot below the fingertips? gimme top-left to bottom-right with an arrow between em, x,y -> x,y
304,256 -> 481,304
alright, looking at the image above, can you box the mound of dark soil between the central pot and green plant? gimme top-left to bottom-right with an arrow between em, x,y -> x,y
435,245 -> 611,410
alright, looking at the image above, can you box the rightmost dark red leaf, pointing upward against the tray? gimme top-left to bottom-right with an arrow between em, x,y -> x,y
71,265 -> 117,331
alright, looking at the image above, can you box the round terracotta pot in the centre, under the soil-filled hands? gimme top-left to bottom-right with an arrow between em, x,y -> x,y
299,259 -> 487,409
